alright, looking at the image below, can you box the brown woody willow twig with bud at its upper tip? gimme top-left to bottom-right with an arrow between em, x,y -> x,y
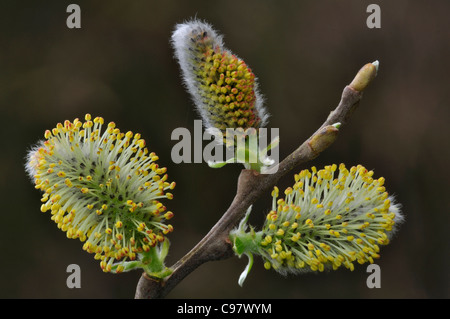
135,62 -> 378,299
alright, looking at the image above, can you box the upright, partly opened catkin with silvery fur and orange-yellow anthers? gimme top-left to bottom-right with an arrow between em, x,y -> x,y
172,20 -> 268,131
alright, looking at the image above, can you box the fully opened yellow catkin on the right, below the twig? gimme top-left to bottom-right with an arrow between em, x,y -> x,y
231,164 -> 403,282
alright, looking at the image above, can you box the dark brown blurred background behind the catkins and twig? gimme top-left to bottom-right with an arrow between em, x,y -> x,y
0,0 -> 450,298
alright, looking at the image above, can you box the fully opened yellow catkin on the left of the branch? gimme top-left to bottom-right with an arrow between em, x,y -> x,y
27,114 -> 175,272
